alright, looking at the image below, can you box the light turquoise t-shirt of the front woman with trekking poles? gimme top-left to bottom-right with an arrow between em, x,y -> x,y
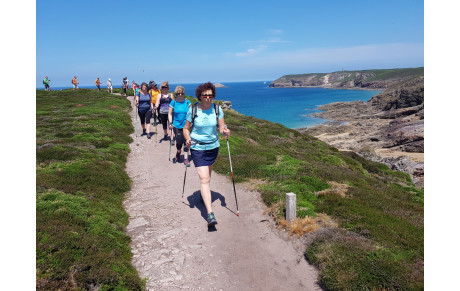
187,104 -> 224,151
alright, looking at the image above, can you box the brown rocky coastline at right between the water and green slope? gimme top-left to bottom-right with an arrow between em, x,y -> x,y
299,76 -> 424,188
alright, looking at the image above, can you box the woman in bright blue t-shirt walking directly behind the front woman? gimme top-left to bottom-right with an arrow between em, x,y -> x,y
168,85 -> 191,166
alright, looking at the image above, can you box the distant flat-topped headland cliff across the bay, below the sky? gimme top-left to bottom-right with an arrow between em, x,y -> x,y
270,67 -> 424,89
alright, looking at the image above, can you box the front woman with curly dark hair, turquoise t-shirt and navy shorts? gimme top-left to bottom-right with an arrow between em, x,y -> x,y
183,82 -> 230,226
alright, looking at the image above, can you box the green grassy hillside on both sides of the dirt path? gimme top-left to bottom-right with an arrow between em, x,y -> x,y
36,89 -> 424,290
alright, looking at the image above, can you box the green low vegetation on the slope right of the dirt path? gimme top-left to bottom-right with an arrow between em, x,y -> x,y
214,110 -> 424,290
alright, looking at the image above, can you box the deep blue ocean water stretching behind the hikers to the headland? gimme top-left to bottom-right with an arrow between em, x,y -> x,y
42,81 -> 382,129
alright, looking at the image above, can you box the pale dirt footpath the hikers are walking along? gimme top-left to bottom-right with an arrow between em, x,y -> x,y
124,97 -> 321,290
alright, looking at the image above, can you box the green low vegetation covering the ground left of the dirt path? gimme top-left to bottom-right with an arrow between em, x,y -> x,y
36,89 -> 145,290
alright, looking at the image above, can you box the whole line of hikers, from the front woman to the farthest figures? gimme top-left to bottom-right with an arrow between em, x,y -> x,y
43,76 -> 232,227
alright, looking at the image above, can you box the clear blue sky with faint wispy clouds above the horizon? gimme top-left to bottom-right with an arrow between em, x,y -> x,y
36,0 -> 424,87
